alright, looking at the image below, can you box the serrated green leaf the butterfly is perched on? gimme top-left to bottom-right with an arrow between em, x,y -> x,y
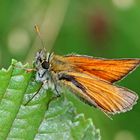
0,60 -> 100,140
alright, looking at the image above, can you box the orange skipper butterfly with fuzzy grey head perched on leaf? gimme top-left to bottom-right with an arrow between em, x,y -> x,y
34,49 -> 140,114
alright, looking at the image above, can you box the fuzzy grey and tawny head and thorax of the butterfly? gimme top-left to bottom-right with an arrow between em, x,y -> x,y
34,50 -> 70,90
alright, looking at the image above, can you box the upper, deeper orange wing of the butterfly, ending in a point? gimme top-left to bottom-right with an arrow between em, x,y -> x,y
65,55 -> 140,83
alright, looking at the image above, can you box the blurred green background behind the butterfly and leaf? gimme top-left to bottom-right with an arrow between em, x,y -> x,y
0,0 -> 140,140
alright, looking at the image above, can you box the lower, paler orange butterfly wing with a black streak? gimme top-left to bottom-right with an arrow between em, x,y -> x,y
59,72 -> 138,114
